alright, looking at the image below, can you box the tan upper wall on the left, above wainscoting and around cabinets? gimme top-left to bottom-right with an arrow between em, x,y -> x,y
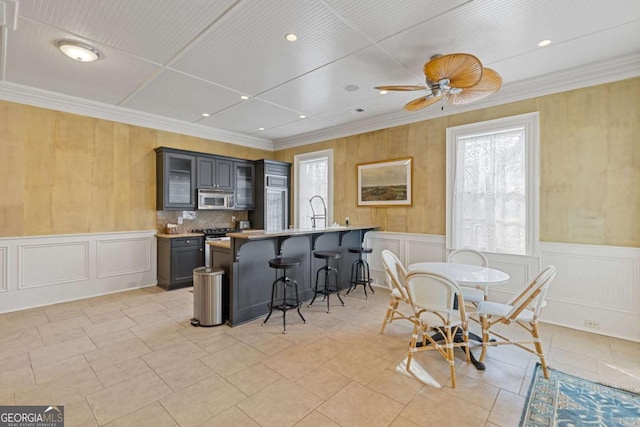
0,101 -> 273,237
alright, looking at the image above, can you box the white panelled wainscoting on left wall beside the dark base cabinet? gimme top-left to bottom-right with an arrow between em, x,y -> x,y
0,230 -> 157,313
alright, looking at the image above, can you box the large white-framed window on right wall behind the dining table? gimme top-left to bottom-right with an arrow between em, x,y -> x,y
447,113 -> 539,255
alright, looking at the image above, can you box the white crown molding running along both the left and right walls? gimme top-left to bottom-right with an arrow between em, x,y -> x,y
0,53 -> 640,151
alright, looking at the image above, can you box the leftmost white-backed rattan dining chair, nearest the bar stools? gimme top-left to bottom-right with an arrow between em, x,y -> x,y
380,249 -> 412,334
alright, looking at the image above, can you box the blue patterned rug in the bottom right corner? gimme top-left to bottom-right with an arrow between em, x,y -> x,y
520,363 -> 640,427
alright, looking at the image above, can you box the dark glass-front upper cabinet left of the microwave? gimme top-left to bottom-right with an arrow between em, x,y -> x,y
155,147 -> 196,210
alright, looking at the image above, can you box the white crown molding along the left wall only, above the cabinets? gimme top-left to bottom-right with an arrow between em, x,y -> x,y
0,81 -> 273,151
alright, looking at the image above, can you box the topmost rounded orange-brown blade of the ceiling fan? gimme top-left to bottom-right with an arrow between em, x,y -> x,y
424,53 -> 482,89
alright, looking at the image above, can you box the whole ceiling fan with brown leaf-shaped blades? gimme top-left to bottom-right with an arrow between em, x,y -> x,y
375,53 -> 502,111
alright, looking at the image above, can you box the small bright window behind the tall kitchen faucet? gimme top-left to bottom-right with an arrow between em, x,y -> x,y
294,150 -> 333,228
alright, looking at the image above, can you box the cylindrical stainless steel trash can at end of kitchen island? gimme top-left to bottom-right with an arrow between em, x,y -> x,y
191,267 -> 224,327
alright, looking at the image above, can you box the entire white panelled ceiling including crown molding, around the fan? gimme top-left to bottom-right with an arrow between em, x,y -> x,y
0,0 -> 640,148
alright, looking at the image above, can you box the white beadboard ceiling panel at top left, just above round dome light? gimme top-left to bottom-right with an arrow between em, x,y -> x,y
19,0 -> 237,63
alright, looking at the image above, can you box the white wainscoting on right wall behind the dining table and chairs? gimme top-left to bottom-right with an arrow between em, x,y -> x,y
364,231 -> 640,342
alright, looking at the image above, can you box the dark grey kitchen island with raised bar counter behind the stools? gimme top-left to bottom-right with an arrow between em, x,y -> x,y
211,226 -> 376,326
